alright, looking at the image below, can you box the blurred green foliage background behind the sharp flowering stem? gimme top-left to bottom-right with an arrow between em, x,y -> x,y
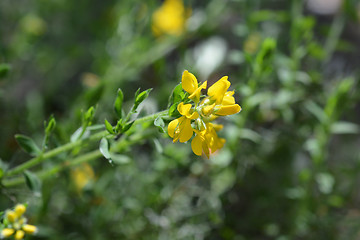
0,0 -> 360,240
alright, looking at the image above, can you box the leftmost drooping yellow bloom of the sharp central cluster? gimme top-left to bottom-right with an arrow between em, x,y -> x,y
168,103 -> 199,142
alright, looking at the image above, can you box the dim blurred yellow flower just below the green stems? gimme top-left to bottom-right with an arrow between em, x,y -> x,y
71,163 -> 95,192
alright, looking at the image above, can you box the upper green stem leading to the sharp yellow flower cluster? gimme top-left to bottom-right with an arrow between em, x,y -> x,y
5,110 -> 168,177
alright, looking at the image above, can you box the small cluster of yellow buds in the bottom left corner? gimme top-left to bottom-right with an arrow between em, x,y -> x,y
0,204 -> 37,240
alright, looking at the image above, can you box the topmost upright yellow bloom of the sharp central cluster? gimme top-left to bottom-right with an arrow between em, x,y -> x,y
181,70 -> 207,103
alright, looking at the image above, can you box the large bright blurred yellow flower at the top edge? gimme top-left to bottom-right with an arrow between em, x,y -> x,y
152,0 -> 190,36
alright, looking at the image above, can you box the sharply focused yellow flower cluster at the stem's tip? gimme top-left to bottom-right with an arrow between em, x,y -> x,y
168,70 -> 241,158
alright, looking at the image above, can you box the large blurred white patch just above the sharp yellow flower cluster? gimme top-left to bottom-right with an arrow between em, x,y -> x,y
194,37 -> 227,79
